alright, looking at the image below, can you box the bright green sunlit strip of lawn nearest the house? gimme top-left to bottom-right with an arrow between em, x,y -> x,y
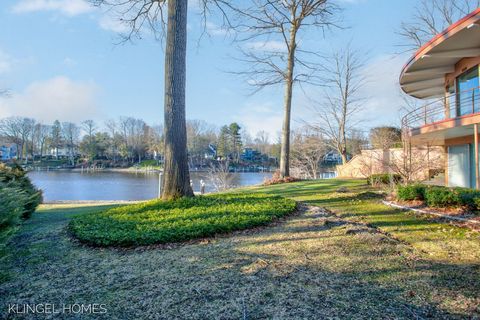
248,179 -> 480,263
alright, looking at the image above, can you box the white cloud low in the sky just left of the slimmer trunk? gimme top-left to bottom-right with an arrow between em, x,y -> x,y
233,102 -> 283,140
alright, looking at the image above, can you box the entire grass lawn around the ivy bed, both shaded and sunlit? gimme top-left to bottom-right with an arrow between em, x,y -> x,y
0,180 -> 480,319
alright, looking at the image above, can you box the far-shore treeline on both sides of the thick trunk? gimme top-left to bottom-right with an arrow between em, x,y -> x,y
0,117 -> 279,167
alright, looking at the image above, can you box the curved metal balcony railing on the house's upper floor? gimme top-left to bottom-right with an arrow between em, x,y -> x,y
402,87 -> 480,132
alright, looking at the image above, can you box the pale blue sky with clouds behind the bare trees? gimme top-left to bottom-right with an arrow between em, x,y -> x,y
0,0 -> 416,139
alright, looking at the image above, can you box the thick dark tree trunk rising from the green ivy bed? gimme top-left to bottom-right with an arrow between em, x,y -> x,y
162,0 -> 193,199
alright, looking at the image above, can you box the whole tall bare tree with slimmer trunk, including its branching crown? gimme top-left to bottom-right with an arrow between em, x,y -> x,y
217,0 -> 338,177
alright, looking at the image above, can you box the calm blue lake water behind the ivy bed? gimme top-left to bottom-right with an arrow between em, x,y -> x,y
28,171 -> 271,201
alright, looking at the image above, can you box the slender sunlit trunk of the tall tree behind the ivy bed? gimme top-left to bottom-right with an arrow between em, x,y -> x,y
280,26 -> 296,178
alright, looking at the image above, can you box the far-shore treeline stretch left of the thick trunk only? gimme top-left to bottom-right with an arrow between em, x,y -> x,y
0,117 -> 163,165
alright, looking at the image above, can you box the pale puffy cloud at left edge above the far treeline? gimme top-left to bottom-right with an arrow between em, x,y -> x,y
0,76 -> 98,123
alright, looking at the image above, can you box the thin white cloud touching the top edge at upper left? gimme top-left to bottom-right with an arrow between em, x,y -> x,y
12,0 -> 94,16
